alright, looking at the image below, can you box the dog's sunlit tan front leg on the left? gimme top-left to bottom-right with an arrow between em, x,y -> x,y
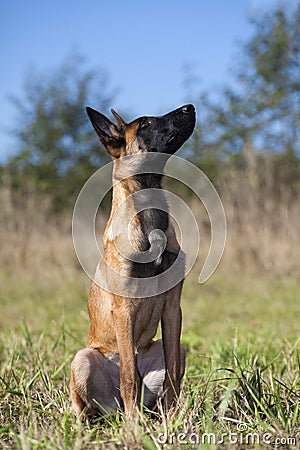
113,298 -> 140,417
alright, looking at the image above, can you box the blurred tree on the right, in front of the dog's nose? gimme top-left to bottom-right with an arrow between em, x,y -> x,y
190,2 -> 300,159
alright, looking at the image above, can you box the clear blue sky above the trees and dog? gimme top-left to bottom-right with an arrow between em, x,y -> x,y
0,0 -> 292,161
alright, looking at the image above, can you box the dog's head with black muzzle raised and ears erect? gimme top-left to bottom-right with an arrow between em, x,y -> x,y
86,105 -> 195,159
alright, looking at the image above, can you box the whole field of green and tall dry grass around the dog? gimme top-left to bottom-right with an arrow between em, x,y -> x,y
0,167 -> 300,450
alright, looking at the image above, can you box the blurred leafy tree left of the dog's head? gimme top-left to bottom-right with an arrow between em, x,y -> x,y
8,55 -> 114,210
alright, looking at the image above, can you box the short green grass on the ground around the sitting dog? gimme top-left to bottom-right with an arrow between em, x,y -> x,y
0,269 -> 300,450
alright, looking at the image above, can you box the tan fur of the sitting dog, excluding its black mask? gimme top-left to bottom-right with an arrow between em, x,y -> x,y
70,103 -> 195,416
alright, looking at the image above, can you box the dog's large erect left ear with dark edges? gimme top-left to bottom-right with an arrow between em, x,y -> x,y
86,107 -> 125,158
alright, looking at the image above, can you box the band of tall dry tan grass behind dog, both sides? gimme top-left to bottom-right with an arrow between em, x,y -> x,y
0,149 -> 300,277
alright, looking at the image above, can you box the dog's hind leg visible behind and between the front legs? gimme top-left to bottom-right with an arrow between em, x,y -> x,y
137,340 -> 185,409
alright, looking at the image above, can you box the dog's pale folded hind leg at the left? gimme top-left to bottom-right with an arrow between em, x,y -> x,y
70,348 -> 121,416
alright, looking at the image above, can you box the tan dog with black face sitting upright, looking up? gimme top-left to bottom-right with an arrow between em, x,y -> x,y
70,105 -> 195,418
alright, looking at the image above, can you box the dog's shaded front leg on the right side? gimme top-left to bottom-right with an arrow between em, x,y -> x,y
162,283 -> 185,411
